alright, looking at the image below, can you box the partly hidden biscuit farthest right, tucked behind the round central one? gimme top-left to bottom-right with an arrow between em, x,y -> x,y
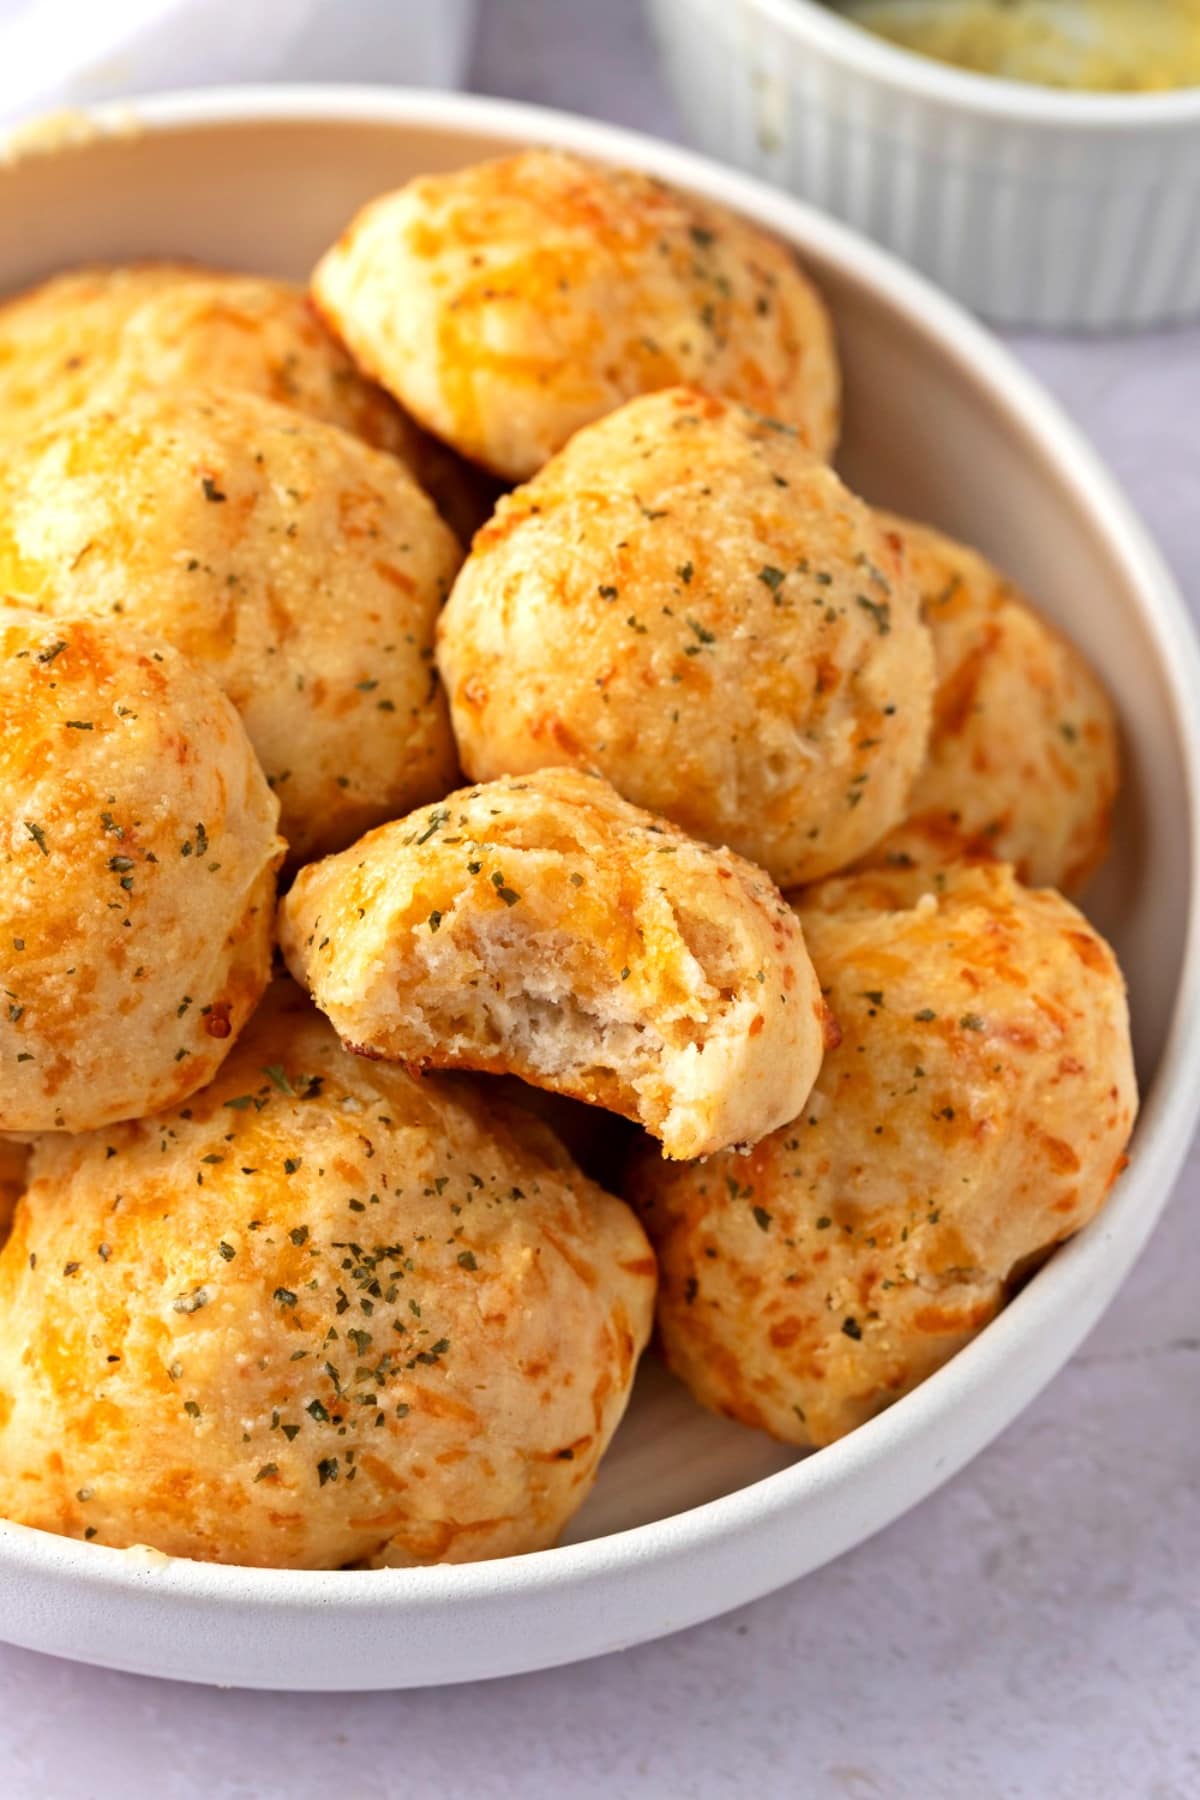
865,515 -> 1119,891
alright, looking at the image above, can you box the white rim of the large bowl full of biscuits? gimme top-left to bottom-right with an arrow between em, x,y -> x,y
0,85 -> 1200,1634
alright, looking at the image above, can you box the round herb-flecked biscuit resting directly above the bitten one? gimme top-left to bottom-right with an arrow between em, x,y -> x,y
437,387 -> 934,886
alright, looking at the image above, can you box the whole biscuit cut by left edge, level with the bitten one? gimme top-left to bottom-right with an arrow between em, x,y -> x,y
0,608 -> 282,1132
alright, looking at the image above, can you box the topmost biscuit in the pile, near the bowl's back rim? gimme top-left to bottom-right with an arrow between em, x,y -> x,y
313,149 -> 840,481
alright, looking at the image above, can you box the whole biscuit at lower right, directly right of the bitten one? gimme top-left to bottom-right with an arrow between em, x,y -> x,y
631,864 -> 1137,1444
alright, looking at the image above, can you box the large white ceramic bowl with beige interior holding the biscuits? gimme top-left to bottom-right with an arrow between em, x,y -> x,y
0,88 -> 1200,1688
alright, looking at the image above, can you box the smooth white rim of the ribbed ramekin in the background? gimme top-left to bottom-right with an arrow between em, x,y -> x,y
698,0 -> 1200,135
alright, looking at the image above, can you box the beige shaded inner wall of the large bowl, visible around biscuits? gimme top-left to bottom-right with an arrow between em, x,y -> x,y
0,117 -> 1193,1541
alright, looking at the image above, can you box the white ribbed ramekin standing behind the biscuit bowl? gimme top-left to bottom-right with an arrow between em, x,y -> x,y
648,0 -> 1200,329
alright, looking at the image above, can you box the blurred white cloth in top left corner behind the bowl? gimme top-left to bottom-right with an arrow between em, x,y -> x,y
0,0 -> 477,122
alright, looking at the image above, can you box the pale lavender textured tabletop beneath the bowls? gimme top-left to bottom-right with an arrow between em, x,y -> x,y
0,0 -> 1200,1800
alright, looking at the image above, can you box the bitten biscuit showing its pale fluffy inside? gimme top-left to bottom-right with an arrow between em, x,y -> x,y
279,769 -> 828,1156
